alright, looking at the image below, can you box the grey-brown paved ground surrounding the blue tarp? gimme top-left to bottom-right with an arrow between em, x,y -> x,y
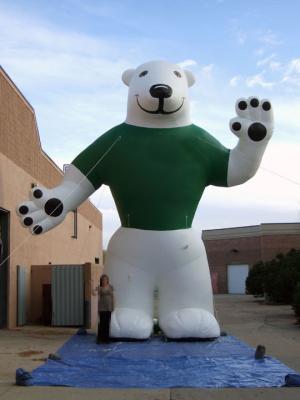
0,295 -> 300,400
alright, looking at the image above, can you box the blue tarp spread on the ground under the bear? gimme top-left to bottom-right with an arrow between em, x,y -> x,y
32,334 -> 295,388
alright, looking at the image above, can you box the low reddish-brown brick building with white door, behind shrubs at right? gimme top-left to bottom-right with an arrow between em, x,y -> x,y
202,223 -> 300,293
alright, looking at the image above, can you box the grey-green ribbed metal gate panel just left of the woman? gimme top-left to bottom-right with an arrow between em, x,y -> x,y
52,265 -> 84,326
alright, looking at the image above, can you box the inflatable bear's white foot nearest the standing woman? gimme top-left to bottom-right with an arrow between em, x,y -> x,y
110,308 -> 153,339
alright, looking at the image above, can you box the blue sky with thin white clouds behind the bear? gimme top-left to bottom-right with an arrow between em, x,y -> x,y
0,0 -> 300,247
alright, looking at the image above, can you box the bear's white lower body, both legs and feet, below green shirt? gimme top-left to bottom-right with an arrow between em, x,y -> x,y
105,228 -> 220,339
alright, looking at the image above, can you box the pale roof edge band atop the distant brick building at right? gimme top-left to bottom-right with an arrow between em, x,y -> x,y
202,222 -> 300,240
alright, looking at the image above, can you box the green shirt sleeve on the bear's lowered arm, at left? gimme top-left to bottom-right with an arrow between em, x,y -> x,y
72,131 -> 120,190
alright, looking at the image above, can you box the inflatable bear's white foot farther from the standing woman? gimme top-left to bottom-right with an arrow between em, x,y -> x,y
159,308 -> 220,339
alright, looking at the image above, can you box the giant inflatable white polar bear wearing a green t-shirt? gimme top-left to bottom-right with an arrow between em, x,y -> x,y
18,61 -> 273,339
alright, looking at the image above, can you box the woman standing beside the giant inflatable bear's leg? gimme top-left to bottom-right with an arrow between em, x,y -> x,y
97,274 -> 114,343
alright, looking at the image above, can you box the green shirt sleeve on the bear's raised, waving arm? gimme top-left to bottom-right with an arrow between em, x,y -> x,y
200,130 -> 230,187
